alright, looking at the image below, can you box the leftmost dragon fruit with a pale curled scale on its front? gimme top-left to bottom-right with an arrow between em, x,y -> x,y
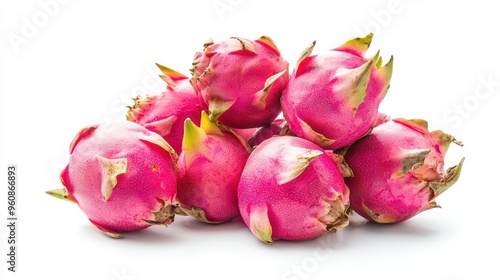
47,121 -> 182,238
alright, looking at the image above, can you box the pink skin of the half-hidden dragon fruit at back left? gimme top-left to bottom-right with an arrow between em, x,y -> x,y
127,77 -> 204,154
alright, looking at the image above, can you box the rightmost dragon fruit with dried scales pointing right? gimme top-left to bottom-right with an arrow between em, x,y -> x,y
345,119 -> 464,223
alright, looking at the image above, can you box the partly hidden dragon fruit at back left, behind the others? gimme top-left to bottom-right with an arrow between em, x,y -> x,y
127,64 -> 203,153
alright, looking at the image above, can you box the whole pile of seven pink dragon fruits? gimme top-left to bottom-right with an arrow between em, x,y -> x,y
47,34 -> 464,243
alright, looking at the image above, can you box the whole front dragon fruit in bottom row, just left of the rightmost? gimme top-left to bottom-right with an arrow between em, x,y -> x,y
238,136 -> 350,243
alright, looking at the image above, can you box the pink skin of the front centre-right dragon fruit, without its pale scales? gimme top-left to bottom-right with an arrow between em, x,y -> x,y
238,136 -> 349,240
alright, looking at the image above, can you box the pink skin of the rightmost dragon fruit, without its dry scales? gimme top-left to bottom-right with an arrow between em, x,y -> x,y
345,121 -> 445,222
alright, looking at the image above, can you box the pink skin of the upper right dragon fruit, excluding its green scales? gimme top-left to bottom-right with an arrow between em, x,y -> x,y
281,50 -> 385,150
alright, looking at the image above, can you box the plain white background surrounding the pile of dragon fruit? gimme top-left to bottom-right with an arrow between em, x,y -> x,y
0,0 -> 500,280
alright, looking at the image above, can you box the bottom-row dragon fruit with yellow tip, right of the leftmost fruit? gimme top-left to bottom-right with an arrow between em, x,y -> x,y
178,111 -> 250,223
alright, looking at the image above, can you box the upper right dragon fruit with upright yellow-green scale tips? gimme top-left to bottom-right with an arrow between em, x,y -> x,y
281,34 -> 393,150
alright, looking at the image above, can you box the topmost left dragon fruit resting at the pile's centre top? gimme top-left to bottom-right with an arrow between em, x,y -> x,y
191,36 -> 289,128
